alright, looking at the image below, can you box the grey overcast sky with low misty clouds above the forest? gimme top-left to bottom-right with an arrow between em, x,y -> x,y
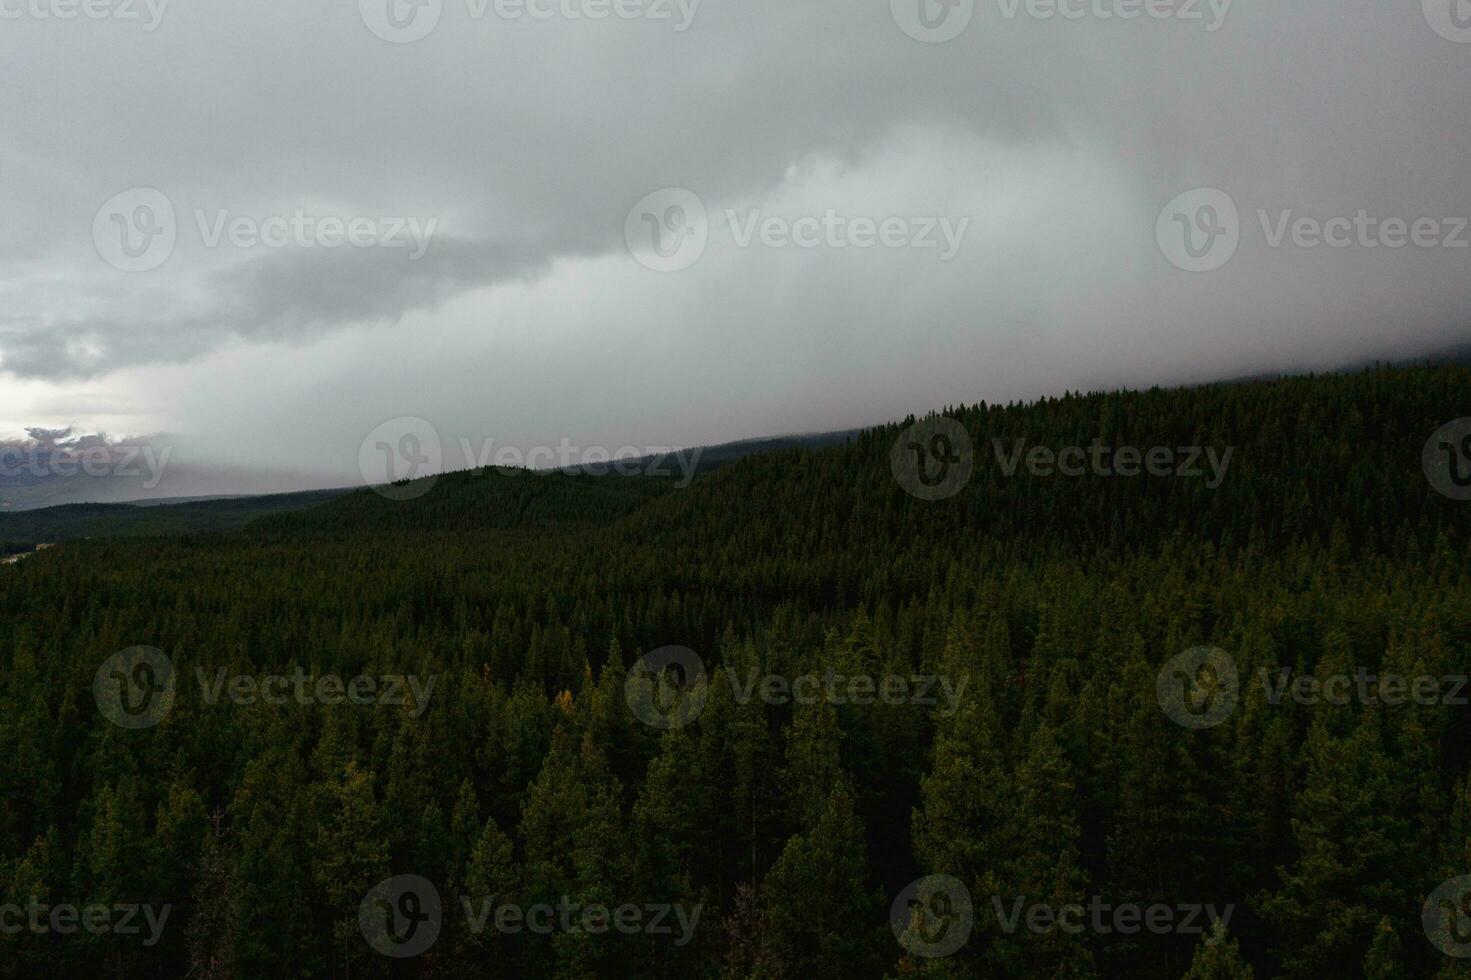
0,0 -> 1471,489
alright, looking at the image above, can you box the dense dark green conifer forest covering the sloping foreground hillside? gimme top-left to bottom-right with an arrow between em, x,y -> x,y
0,366 -> 1471,980
